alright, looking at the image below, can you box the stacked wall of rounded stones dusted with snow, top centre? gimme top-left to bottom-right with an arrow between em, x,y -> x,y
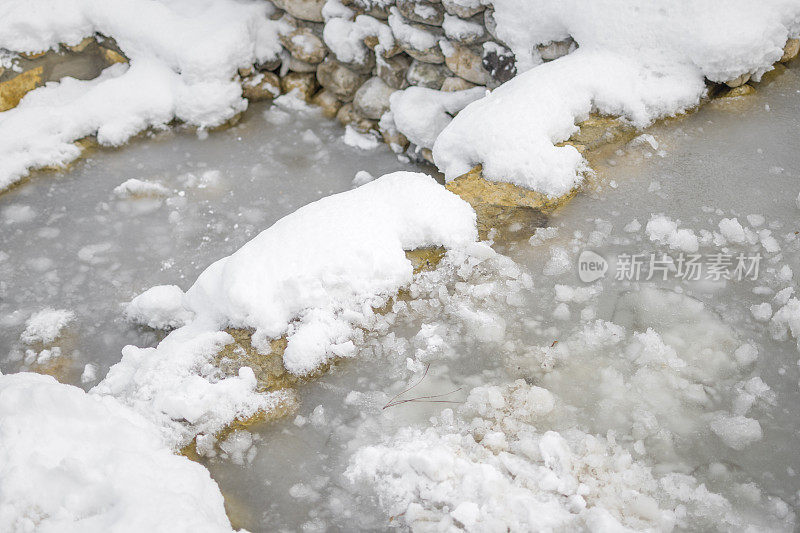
240,0 -> 575,155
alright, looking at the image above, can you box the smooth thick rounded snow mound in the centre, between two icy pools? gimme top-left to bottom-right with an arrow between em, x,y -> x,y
186,172 -> 477,374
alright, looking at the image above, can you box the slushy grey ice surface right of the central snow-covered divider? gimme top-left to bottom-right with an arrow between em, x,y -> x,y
195,69 -> 800,530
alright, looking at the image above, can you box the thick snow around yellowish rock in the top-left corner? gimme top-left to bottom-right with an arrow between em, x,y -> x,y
0,0 -> 282,190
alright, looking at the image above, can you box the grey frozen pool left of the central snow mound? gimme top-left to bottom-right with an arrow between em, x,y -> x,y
0,96 -> 411,382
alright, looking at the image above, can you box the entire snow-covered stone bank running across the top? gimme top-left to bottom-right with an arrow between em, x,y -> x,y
0,0 -> 800,209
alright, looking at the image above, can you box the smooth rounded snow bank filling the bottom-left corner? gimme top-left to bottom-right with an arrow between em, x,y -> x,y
0,373 -> 232,533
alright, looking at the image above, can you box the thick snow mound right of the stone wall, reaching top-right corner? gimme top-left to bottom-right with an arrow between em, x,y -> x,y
432,0 -> 800,196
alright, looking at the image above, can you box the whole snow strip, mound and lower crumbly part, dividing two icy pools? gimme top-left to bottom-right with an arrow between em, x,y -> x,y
95,172 -> 477,444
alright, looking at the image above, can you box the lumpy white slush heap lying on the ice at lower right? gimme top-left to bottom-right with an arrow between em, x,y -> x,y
346,287 -> 794,531
